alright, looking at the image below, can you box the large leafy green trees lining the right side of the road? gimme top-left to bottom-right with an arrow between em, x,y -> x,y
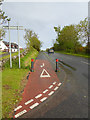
53,18 -> 90,53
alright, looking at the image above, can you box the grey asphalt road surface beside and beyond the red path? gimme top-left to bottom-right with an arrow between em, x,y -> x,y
18,53 -> 89,118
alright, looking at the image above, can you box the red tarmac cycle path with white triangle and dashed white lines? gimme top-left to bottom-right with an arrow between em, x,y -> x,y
14,60 -> 61,118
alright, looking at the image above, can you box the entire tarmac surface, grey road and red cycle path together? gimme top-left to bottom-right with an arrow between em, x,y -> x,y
14,53 -> 89,118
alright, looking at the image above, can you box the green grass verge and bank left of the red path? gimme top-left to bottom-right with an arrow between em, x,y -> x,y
2,49 -> 38,118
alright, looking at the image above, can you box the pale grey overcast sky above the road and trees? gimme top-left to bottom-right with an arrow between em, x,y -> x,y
2,0 -> 88,49
